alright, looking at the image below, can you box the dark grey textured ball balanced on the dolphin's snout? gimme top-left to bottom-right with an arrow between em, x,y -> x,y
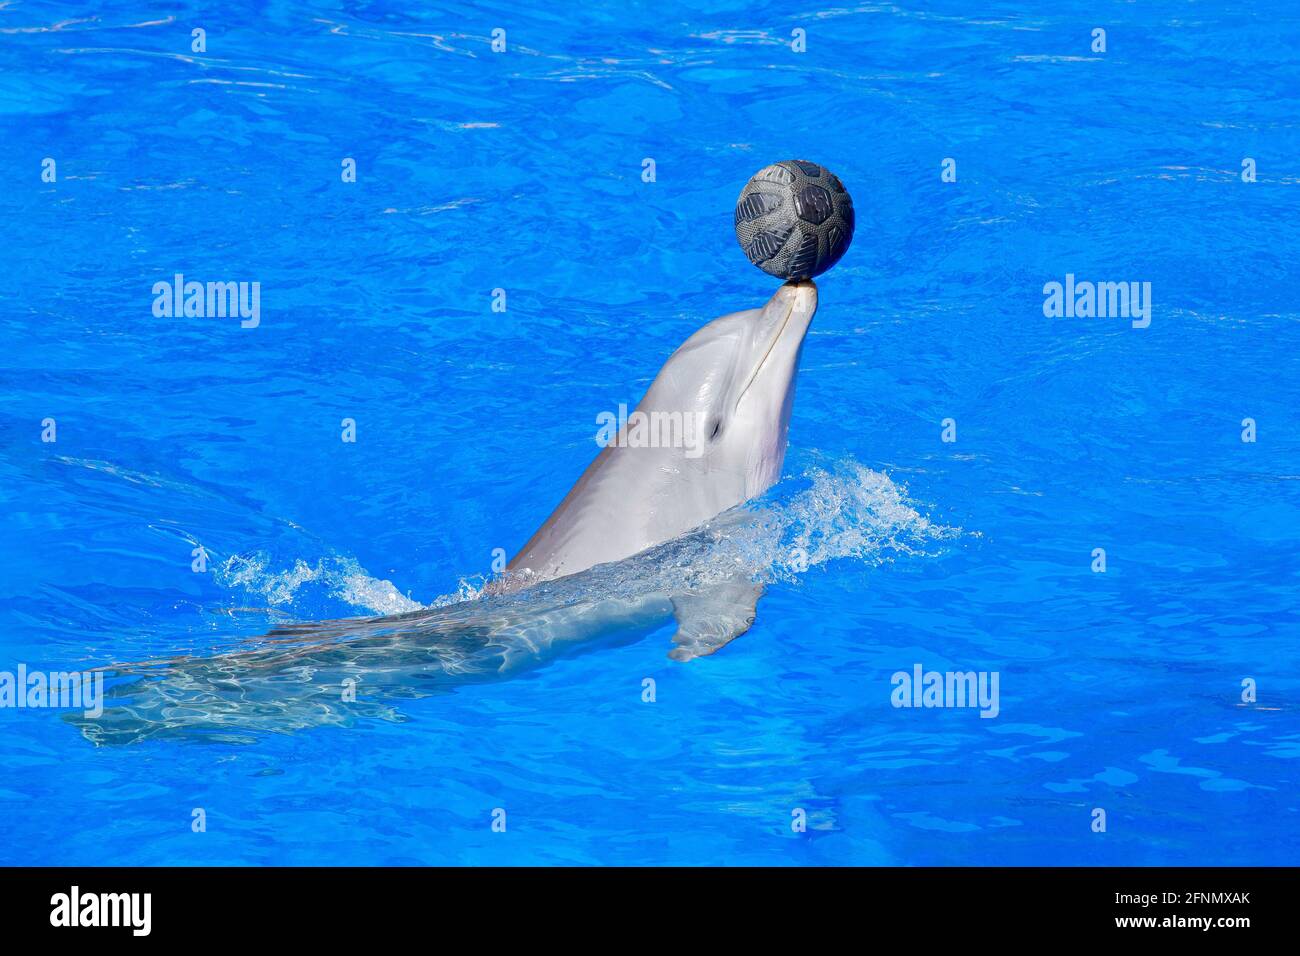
736,160 -> 853,278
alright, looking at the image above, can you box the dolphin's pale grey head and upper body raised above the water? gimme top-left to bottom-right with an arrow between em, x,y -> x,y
510,280 -> 816,580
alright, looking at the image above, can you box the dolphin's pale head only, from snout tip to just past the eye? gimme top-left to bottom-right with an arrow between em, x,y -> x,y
640,280 -> 816,502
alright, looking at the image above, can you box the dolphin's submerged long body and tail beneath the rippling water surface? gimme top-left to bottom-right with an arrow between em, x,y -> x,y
65,509 -> 764,745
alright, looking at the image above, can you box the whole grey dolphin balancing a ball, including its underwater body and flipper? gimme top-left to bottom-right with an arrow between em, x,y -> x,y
68,281 -> 816,744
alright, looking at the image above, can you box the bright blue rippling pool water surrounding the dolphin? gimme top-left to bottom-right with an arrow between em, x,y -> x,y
0,0 -> 1300,865
